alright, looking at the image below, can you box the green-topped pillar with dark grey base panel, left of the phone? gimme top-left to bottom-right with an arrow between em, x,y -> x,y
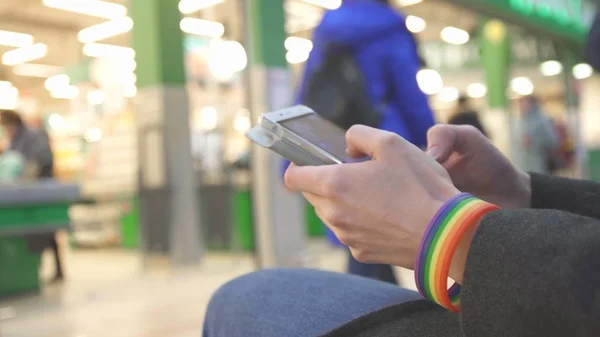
130,0 -> 202,265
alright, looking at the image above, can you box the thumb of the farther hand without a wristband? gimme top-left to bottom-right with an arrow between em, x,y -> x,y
427,125 -> 487,163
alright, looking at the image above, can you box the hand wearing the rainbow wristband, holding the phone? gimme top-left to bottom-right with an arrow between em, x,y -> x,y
285,126 -> 459,269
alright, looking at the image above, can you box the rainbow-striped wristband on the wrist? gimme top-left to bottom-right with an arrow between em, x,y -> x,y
415,193 -> 498,312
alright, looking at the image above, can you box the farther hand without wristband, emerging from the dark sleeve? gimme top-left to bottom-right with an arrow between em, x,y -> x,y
427,125 -> 531,209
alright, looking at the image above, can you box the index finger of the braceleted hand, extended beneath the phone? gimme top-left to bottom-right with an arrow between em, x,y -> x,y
284,164 -> 335,195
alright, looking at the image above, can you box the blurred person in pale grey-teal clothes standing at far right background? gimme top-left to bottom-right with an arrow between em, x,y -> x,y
519,96 -> 558,174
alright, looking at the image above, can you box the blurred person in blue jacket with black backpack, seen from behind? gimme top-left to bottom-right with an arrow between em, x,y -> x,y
285,0 -> 434,283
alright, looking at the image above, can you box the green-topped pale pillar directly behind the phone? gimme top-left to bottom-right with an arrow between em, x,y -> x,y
244,0 -> 306,268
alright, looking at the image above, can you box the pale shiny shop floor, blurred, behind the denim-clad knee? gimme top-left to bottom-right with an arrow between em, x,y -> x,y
0,242 -> 418,337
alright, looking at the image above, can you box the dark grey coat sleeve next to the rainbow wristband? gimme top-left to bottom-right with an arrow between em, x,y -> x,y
461,209 -> 600,337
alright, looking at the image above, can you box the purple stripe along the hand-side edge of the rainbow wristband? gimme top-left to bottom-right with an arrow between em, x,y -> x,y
415,193 -> 472,297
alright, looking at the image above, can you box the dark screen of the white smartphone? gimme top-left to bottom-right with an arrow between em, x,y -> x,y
280,113 -> 357,163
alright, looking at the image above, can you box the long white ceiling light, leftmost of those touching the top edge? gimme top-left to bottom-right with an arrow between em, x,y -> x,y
43,0 -> 127,19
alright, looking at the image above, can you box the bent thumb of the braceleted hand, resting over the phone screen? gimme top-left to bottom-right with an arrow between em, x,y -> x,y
346,125 -> 402,158
